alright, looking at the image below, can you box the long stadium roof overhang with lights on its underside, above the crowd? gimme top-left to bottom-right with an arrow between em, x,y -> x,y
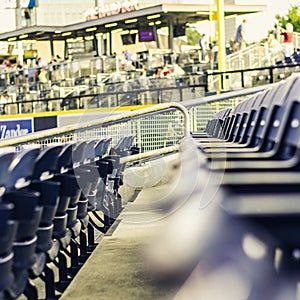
0,4 -> 266,41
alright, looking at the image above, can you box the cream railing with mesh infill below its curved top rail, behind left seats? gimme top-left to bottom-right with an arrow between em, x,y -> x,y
0,102 -> 190,155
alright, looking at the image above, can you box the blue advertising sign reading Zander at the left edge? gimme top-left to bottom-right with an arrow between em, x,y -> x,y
0,119 -> 33,139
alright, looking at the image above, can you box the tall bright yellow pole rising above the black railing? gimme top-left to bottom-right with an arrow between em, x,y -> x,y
216,0 -> 226,89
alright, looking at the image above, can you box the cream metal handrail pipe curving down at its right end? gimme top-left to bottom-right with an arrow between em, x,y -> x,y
0,102 -> 190,147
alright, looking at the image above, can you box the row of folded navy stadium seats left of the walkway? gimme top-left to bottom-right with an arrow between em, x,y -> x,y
0,136 -> 138,299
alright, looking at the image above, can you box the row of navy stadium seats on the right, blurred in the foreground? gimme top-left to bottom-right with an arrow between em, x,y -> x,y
183,74 -> 300,299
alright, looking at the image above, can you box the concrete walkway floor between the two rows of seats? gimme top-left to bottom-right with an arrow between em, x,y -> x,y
61,185 -> 183,300
